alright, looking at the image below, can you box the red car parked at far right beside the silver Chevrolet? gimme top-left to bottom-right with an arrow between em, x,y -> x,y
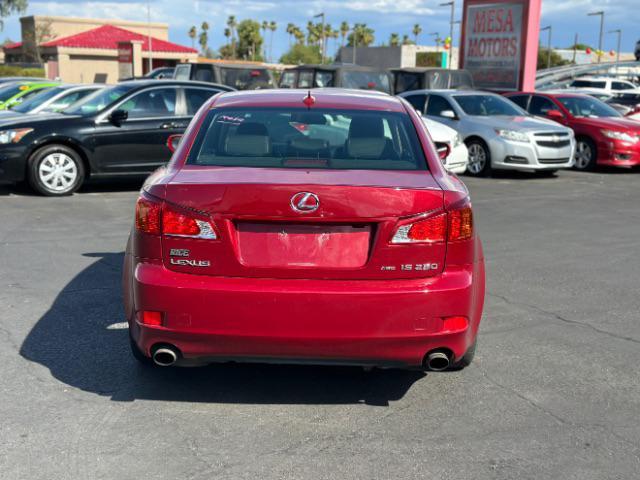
506,92 -> 640,170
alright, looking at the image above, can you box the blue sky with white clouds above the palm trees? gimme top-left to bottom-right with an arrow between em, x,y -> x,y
0,0 -> 640,61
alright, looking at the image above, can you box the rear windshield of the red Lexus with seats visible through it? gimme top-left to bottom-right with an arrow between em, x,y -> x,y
187,108 -> 427,170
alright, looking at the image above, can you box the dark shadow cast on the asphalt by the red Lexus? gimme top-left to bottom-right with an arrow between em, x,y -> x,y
20,252 -> 425,406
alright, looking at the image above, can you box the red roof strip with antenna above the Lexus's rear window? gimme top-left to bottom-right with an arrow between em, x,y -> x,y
214,88 -> 406,112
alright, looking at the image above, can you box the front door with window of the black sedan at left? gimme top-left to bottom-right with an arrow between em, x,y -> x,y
91,86 -> 180,174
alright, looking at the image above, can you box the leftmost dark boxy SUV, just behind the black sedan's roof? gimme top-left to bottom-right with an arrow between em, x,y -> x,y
173,63 -> 275,90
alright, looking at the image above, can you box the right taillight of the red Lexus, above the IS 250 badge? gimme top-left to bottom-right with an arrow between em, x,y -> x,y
391,207 -> 473,243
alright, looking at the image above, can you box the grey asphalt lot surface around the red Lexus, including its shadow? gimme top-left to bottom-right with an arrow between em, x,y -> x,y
0,171 -> 640,480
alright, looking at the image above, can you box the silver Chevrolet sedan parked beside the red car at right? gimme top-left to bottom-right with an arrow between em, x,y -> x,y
400,90 -> 575,176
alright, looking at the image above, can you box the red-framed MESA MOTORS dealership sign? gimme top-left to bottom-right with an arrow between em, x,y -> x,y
460,0 -> 542,91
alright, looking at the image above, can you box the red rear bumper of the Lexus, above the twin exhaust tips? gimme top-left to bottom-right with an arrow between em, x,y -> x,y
125,262 -> 484,366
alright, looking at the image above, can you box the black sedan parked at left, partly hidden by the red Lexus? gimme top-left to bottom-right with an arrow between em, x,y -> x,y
0,80 -> 233,196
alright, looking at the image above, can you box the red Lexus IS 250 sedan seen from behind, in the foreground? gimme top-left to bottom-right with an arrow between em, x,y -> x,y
124,90 -> 485,370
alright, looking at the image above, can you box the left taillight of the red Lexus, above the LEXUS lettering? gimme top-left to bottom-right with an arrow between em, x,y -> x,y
136,197 -> 218,240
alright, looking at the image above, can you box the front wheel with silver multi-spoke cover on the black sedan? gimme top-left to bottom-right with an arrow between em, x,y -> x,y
27,145 -> 85,197
